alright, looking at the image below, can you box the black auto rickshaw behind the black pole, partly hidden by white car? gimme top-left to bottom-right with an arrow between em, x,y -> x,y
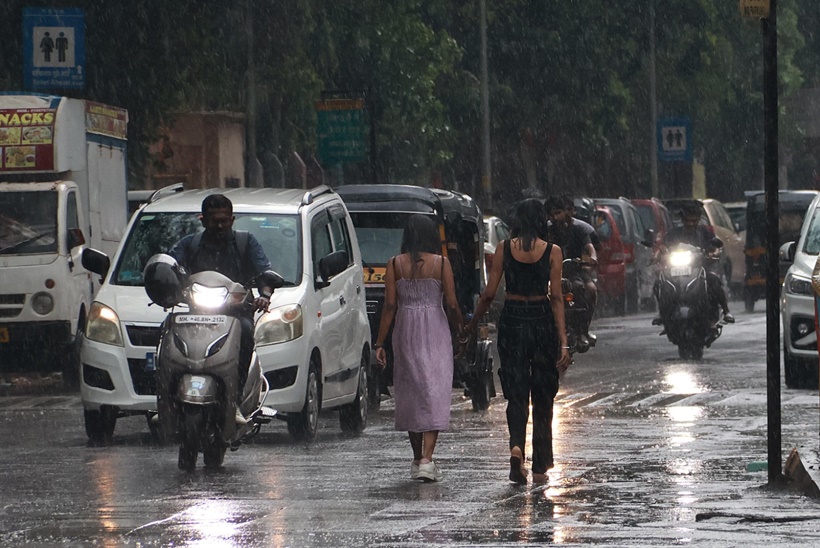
743,190 -> 817,312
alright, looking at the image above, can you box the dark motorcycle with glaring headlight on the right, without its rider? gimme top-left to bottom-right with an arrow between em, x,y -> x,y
655,240 -> 722,360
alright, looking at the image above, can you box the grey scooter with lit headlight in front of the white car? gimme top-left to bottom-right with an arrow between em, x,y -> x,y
143,254 -> 284,470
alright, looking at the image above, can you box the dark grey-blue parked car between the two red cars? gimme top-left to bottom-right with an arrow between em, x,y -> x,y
595,198 -> 655,313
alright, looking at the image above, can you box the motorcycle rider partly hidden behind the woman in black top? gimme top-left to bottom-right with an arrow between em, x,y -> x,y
547,196 -> 598,344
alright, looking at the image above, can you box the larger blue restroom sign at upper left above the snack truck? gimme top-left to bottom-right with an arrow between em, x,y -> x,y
23,8 -> 85,90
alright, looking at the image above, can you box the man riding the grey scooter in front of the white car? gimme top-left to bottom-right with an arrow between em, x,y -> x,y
168,194 -> 273,424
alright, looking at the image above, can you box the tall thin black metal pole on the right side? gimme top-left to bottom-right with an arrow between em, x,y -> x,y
763,0 -> 783,485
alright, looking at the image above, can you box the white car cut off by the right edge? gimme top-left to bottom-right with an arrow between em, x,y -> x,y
780,194 -> 820,389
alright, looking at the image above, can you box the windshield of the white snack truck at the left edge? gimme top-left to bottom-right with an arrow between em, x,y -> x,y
0,191 -> 57,255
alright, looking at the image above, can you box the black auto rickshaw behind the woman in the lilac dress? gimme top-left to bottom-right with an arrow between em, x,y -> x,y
336,185 -> 496,410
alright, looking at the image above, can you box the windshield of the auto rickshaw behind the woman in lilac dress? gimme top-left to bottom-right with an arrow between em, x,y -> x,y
350,211 -> 432,266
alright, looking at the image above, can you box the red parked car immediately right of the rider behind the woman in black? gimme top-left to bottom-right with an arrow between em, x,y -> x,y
591,205 -> 627,315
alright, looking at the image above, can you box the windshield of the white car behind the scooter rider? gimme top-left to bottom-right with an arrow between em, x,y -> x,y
112,212 -> 302,286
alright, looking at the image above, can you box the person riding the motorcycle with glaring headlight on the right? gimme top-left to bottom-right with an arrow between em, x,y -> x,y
652,201 -> 735,325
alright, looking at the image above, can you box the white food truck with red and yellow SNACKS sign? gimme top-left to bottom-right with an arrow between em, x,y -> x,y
0,93 -> 128,385
